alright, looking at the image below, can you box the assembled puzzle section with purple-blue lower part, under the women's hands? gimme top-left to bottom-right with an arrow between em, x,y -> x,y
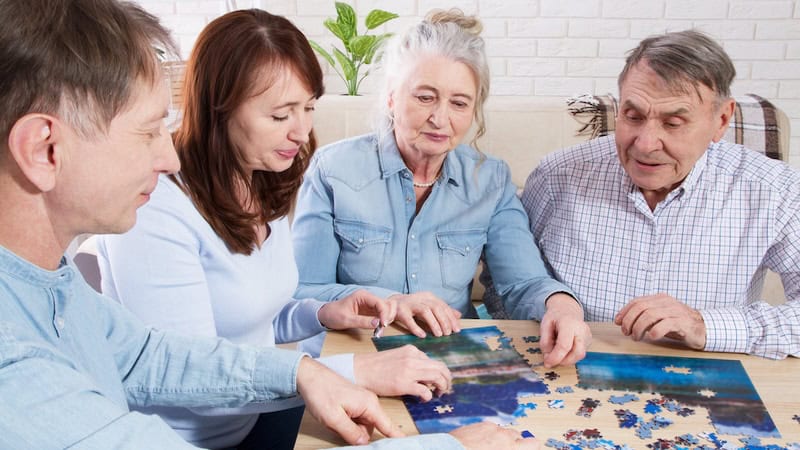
372,326 -> 549,433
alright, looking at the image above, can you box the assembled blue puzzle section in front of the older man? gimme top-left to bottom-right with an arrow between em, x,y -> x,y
576,352 -> 780,437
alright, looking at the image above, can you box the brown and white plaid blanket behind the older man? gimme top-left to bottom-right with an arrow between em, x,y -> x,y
567,94 -> 788,161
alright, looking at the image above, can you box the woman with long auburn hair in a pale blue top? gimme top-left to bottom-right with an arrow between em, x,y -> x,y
98,9 -> 451,450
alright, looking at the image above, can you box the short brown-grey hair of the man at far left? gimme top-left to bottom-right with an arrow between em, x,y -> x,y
0,0 -> 176,141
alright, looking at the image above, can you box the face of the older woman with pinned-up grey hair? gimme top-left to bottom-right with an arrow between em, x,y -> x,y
389,56 -> 478,158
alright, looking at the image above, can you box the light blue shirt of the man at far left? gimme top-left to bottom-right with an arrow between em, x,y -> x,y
0,247 -> 463,450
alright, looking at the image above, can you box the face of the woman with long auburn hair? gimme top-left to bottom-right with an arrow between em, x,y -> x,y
228,68 -> 317,172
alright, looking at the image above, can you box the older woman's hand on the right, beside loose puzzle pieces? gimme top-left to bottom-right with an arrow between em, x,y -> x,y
539,293 -> 592,368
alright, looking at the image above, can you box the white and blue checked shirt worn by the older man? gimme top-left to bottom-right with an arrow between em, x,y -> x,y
522,136 -> 800,358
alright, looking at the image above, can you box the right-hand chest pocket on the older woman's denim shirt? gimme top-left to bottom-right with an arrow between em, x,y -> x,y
436,229 -> 486,289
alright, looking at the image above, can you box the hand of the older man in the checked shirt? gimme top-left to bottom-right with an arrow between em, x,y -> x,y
614,293 -> 706,350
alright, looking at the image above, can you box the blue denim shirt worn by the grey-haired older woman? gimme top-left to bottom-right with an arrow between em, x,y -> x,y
293,135 -> 571,319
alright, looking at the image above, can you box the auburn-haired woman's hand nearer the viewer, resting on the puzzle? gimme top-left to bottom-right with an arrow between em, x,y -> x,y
354,345 -> 453,402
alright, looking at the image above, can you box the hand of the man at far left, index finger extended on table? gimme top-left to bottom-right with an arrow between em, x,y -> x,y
297,357 -> 403,445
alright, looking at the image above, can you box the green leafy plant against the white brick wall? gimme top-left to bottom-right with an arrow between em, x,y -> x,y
310,2 -> 398,95
